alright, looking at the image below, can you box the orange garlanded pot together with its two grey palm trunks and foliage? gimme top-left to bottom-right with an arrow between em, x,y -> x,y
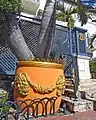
0,0 -> 65,113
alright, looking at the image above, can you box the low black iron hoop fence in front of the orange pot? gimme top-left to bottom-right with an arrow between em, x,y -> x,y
0,97 -> 57,120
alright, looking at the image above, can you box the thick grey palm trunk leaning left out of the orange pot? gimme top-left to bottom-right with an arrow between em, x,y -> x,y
3,14 -> 34,60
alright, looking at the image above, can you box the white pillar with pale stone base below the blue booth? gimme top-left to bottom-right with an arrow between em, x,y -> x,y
77,56 -> 96,99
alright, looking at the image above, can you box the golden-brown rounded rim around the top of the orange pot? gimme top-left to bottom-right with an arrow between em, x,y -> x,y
17,61 -> 64,69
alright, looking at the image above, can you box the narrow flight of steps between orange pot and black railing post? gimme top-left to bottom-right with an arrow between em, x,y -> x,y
60,78 -> 74,112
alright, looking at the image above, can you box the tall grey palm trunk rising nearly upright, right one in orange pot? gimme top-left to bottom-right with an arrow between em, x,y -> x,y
37,0 -> 56,58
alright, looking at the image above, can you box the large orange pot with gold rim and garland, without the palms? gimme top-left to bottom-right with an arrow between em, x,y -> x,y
14,61 -> 65,113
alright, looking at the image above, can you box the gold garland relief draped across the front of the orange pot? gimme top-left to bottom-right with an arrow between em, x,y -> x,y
14,73 -> 65,96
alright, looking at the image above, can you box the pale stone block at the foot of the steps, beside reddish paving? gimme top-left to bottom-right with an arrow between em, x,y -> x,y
62,96 -> 93,112
